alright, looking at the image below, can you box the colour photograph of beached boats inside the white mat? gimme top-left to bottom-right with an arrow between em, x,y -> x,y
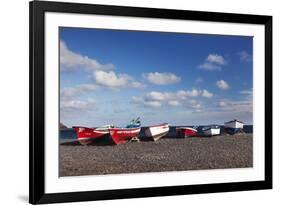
58,27 -> 253,177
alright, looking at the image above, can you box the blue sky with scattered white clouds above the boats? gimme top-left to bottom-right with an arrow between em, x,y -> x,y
60,28 -> 253,127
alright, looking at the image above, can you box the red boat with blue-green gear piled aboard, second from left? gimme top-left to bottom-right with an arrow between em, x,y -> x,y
108,118 -> 141,145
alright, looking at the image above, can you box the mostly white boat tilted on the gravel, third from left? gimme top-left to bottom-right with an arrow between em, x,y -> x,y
144,123 -> 170,141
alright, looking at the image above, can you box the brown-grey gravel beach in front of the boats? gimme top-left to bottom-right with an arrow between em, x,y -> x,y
59,134 -> 253,176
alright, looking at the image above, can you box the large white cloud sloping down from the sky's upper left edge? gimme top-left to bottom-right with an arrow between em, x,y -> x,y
60,40 -> 114,71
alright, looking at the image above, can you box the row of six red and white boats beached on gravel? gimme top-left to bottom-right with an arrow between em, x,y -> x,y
73,118 -> 244,145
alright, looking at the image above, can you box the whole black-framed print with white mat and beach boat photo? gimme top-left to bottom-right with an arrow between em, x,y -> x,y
30,1 -> 272,204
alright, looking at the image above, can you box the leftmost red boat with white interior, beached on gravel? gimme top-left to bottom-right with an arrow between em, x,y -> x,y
72,125 -> 114,145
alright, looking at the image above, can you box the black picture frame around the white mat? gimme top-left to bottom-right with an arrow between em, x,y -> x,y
29,1 -> 272,204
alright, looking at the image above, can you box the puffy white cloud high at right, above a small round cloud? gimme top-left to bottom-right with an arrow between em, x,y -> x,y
198,54 -> 227,71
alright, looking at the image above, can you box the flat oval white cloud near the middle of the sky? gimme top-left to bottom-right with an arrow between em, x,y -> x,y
143,72 -> 181,85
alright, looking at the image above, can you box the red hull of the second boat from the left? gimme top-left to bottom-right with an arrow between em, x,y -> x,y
109,127 -> 141,145
